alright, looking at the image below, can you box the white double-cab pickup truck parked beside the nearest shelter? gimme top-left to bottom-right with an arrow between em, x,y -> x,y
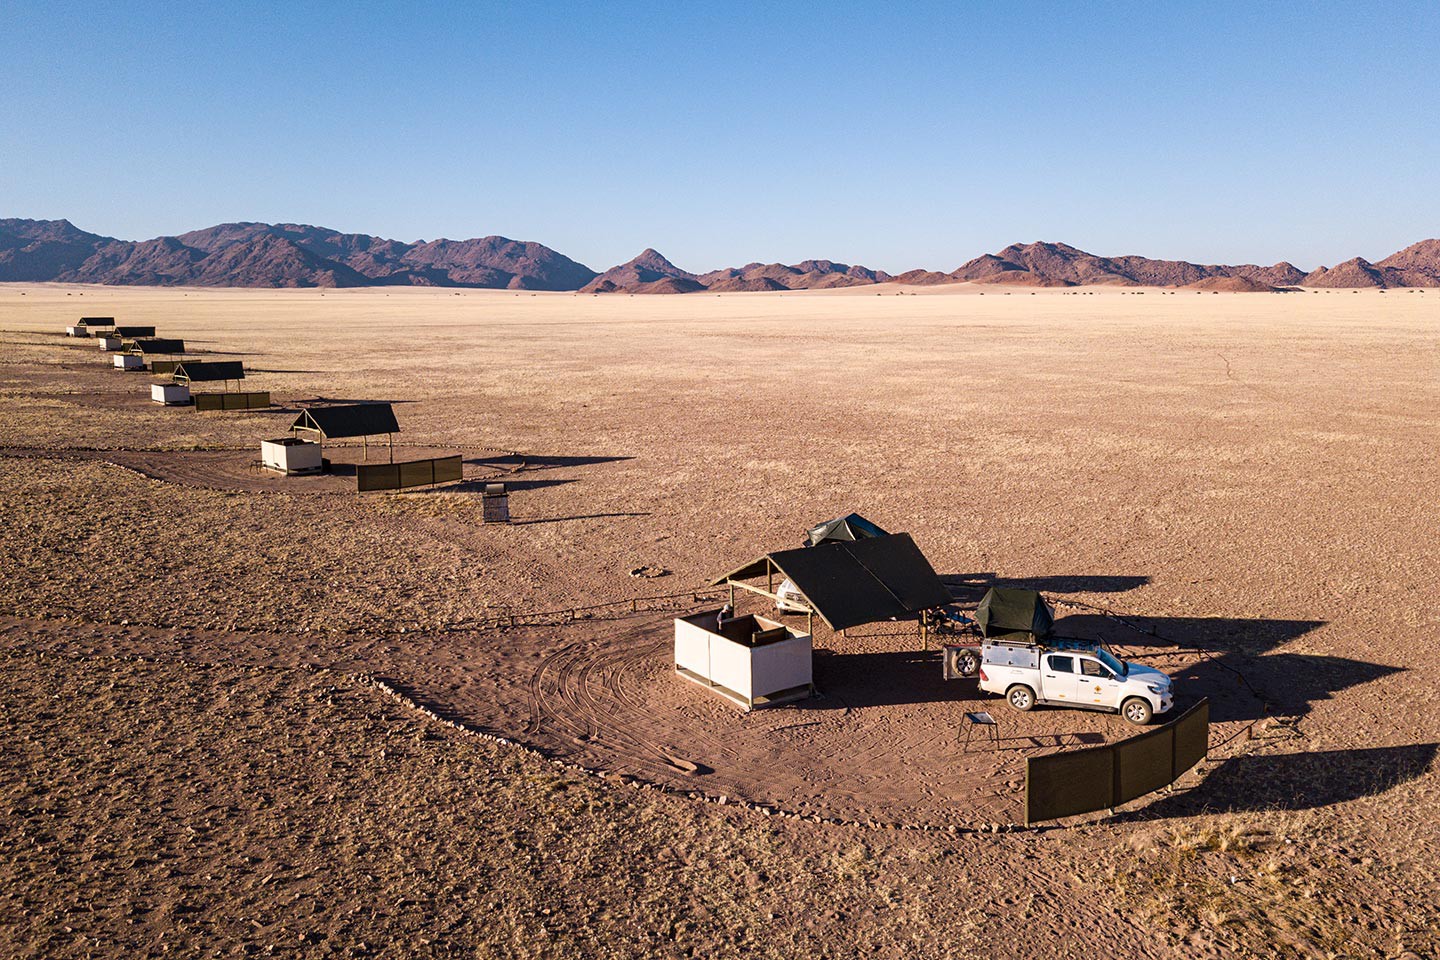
979,643 -> 1175,725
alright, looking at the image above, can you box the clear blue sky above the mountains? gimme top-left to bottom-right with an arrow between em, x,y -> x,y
0,1 -> 1440,272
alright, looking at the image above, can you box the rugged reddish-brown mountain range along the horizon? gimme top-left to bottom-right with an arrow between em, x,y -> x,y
0,220 -> 1440,294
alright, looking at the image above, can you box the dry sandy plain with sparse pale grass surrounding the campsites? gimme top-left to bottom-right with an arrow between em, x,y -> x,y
0,286 -> 1440,957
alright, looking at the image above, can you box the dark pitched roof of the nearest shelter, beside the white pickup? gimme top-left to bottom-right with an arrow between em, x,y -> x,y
710,534 -> 950,630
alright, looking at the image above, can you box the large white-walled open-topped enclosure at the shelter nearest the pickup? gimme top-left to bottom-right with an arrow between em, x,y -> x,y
675,610 -> 815,710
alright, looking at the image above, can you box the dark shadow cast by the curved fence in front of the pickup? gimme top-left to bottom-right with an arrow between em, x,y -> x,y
1117,743 -> 1440,820
